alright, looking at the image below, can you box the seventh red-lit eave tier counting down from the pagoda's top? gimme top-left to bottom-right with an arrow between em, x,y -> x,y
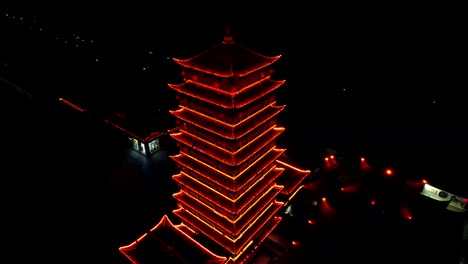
174,185 -> 283,236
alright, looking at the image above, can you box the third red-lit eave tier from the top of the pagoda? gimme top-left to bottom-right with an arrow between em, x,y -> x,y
170,104 -> 284,139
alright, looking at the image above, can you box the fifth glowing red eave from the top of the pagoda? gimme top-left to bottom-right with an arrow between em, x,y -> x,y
171,149 -> 286,192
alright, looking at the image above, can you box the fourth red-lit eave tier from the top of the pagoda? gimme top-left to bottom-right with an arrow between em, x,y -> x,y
170,127 -> 284,166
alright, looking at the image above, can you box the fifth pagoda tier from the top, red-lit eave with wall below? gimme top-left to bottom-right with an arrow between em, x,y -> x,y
171,148 -> 285,193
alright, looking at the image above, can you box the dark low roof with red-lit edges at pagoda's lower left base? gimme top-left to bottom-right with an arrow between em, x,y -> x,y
119,215 -> 226,264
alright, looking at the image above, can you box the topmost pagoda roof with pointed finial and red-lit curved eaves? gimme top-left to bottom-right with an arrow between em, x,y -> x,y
173,29 -> 281,77
